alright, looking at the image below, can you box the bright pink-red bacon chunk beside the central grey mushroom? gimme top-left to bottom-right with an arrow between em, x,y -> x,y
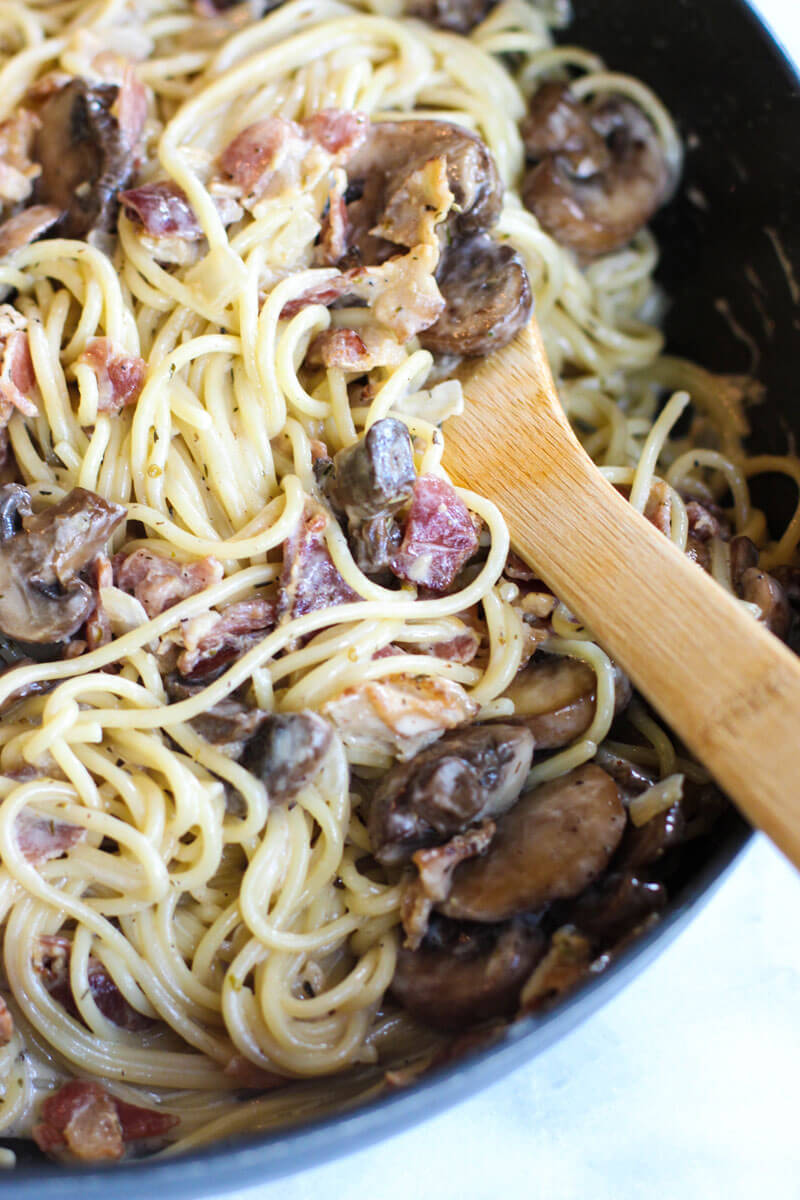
391,475 -> 477,592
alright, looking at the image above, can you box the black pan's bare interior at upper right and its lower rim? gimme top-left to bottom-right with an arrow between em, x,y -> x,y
6,0 -> 800,1200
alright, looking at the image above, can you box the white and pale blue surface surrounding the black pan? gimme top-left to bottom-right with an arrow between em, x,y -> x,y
224,0 -> 800,1200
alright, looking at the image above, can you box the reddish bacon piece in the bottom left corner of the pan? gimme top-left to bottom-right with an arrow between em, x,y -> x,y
32,1079 -> 180,1163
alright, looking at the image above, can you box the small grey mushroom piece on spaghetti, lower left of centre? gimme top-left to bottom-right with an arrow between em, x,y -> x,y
241,713 -> 333,803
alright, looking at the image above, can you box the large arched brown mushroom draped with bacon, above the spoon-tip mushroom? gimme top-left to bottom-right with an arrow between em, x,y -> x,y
345,120 -> 503,263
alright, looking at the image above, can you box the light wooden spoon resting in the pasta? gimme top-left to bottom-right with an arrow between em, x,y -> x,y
444,322 -> 800,866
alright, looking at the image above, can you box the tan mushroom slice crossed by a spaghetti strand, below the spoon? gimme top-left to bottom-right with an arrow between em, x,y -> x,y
505,656 -> 632,750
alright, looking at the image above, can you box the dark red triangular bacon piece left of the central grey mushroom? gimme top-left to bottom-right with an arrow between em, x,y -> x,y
278,500 -> 361,617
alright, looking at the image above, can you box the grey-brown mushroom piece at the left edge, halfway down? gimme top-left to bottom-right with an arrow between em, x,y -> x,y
0,484 -> 125,643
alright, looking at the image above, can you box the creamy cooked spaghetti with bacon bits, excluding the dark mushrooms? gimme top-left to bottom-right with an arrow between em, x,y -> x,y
0,0 -> 800,1158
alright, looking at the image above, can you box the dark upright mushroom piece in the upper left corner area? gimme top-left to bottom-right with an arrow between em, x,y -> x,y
34,78 -> 145,238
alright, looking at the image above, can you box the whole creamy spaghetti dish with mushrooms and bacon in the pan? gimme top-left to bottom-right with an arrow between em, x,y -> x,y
0,0 -> 800,1164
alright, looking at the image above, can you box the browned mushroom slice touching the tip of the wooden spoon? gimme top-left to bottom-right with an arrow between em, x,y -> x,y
420,234 -> 534,358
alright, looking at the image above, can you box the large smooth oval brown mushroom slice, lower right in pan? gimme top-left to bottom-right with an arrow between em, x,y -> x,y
441,763 -> 626,922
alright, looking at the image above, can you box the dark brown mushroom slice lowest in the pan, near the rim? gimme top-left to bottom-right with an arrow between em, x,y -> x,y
391,922 -> 547,1030
